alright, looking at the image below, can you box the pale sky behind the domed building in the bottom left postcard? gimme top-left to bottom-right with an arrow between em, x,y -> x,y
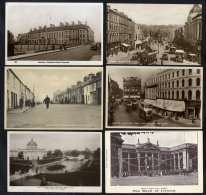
10,132 -> 100,151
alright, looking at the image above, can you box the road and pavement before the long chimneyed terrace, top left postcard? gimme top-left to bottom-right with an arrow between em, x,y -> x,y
8,45 -> 101,61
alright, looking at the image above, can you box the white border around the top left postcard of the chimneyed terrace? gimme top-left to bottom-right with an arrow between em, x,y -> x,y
5,2 -> 104,66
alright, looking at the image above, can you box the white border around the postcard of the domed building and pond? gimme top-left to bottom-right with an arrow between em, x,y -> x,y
7,131 -> 103,193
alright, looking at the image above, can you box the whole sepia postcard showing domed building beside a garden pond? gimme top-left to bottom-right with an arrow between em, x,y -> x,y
8,132 -> 102,192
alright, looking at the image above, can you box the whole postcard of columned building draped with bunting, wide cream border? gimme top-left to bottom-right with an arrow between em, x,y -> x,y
106,131 -> 203,193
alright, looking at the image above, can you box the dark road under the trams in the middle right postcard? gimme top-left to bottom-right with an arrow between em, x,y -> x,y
112,105 -> 187,127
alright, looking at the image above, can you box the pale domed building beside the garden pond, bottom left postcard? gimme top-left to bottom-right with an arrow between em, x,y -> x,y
10,139 -> 48,160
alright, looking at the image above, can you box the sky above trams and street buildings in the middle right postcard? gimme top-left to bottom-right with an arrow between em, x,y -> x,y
108,67 -> 160,89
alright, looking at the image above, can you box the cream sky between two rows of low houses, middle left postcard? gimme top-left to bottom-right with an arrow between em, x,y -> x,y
12,67 -> 101,101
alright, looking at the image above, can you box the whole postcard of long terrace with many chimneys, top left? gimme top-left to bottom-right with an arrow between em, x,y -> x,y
5,3 -> 103,65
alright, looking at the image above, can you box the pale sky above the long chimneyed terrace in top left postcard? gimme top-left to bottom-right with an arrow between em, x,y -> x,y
7,3 -> 102,41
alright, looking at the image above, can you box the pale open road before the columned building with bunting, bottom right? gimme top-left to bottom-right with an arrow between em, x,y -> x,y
111,173 -> 198,186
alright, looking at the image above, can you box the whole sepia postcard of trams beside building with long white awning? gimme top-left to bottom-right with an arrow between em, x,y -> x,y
106,66 -> 203,129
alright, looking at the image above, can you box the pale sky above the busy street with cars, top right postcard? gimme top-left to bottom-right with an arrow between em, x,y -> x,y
108,3 -> 201,25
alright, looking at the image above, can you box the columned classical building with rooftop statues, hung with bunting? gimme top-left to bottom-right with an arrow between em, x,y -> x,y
111,133 -> 198,177
